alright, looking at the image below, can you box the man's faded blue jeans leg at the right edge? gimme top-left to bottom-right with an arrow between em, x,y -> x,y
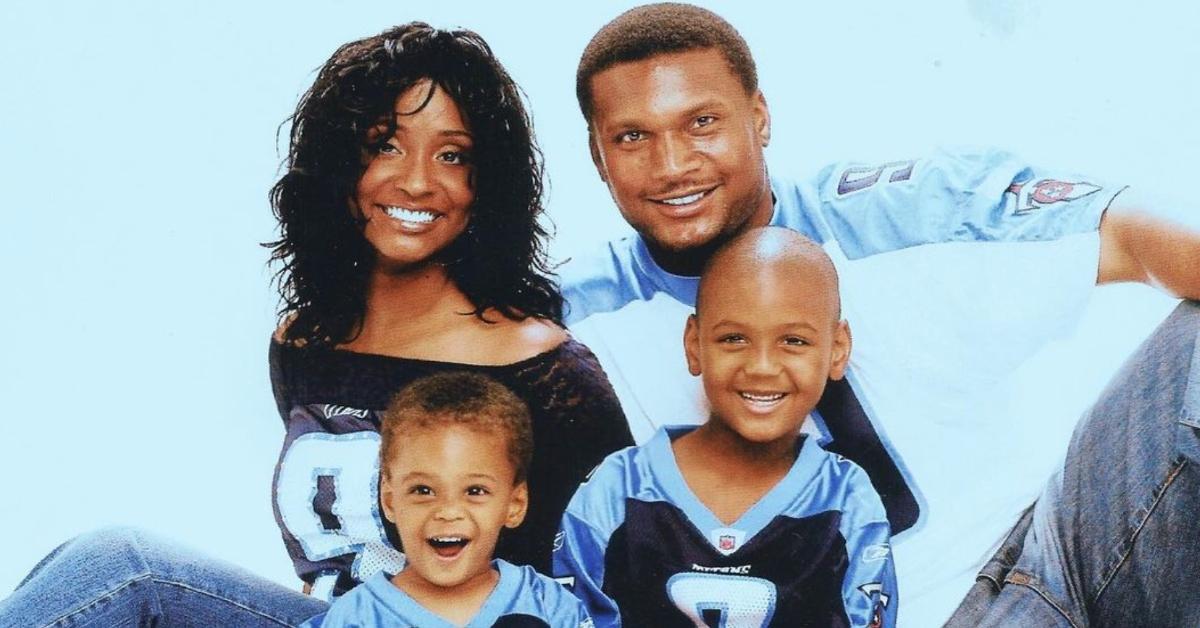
946,301 -> 1200,628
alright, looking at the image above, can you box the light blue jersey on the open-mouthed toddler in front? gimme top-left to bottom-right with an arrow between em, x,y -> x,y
301,560 -> 593,628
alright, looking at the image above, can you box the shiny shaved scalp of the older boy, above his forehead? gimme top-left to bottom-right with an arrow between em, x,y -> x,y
696,227 -> 841,321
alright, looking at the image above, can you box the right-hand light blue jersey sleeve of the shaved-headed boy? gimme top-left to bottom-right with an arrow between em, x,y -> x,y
841,467 -> 900,628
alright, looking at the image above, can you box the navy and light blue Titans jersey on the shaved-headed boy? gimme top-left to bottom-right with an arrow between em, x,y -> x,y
554,427 -> 896,628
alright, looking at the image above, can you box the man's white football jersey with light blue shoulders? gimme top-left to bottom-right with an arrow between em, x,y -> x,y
560,150 -> 1122,626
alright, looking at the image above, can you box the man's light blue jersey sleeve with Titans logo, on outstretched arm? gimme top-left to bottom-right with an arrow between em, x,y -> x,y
785,150 -> 1123,259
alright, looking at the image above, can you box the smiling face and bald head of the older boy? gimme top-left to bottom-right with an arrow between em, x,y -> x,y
684,229 -> 851,444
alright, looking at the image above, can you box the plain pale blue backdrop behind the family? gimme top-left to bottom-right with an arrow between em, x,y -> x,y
0,0 -> 1200,594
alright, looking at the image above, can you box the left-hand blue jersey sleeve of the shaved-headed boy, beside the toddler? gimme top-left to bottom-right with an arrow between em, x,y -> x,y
553,511 -> 620,628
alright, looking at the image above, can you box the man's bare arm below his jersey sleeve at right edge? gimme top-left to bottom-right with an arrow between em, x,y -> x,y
1096,196 -> 1200,299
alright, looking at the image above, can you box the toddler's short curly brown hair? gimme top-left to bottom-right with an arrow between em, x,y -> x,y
379,372 -> 533,483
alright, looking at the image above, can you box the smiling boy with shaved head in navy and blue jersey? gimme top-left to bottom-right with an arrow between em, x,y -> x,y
554,227 -> 896,628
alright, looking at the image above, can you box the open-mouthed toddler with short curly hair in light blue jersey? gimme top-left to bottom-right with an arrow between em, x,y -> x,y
304,372 -> 592,628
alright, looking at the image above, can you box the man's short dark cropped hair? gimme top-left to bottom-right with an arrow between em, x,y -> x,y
575,2 -> 758,124
